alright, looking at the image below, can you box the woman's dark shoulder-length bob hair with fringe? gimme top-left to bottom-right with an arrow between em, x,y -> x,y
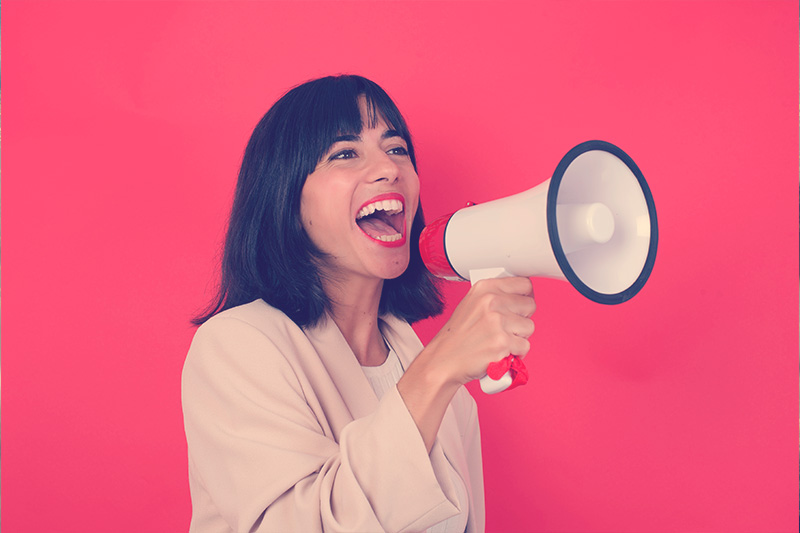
193,75 -> 443,327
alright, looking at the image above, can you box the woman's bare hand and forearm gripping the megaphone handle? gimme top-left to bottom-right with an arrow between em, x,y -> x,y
397,277 -> 536,451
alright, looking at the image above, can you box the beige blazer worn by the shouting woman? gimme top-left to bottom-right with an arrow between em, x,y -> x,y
182,300 -> 484,533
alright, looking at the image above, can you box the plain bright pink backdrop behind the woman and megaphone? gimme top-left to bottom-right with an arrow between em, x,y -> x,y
2,0 -> 798,533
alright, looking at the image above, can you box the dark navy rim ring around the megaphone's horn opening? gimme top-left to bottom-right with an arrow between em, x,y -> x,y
547,141 -> 658,305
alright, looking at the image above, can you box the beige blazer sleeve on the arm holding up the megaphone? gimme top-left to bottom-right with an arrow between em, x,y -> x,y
182,317 -> 458,532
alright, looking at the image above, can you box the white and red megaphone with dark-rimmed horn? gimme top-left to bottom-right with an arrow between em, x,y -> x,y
420,141 -> 658,394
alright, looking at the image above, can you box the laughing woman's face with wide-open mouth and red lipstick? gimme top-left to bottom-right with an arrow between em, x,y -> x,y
300,98 -> 419,286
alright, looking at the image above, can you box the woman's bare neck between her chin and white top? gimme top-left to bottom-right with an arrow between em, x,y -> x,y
325,274 -> 388,366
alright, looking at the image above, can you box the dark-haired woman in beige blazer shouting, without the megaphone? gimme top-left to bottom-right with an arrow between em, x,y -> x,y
183,76 -> 535,532
